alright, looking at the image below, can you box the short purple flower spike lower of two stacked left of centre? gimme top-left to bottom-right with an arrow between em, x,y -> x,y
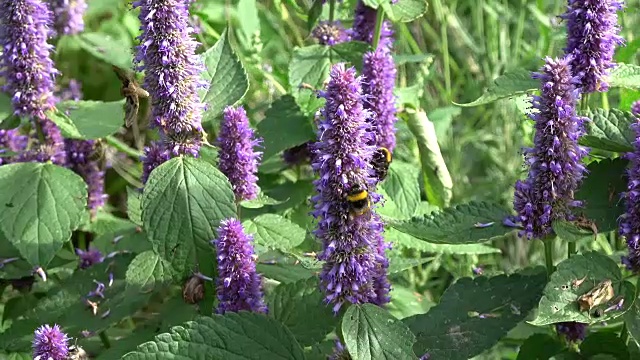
214,219 -> 267,314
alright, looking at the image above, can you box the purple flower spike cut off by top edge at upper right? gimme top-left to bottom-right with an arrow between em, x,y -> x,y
562,0 -> 624,93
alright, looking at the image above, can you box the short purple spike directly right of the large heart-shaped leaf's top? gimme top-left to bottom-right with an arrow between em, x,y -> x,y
218,106 -> 262,201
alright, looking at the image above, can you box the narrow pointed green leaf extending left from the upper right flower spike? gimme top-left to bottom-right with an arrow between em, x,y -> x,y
454,69 -> 540,107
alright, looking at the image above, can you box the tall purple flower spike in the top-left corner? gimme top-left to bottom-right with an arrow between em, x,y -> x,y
0,0 -> 66,165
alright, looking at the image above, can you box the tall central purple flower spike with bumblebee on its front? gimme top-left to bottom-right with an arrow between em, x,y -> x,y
312,64 -> 388,312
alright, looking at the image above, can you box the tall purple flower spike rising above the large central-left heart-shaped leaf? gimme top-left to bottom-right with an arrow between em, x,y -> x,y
133,0 -> 205,181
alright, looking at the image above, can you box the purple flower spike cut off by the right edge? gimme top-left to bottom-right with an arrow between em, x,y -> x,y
620,100 -> 640,273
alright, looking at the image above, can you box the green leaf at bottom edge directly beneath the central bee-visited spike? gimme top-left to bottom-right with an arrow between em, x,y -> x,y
342,304 -> 417,360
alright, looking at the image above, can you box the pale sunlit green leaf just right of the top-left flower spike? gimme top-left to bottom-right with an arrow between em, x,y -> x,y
52,100 -> 124,139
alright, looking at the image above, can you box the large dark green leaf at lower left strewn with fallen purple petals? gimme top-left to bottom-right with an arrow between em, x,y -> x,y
0,254 -> 151,351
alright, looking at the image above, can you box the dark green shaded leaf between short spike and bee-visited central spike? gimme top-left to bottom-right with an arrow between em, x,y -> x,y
257,95 -> 316,160
